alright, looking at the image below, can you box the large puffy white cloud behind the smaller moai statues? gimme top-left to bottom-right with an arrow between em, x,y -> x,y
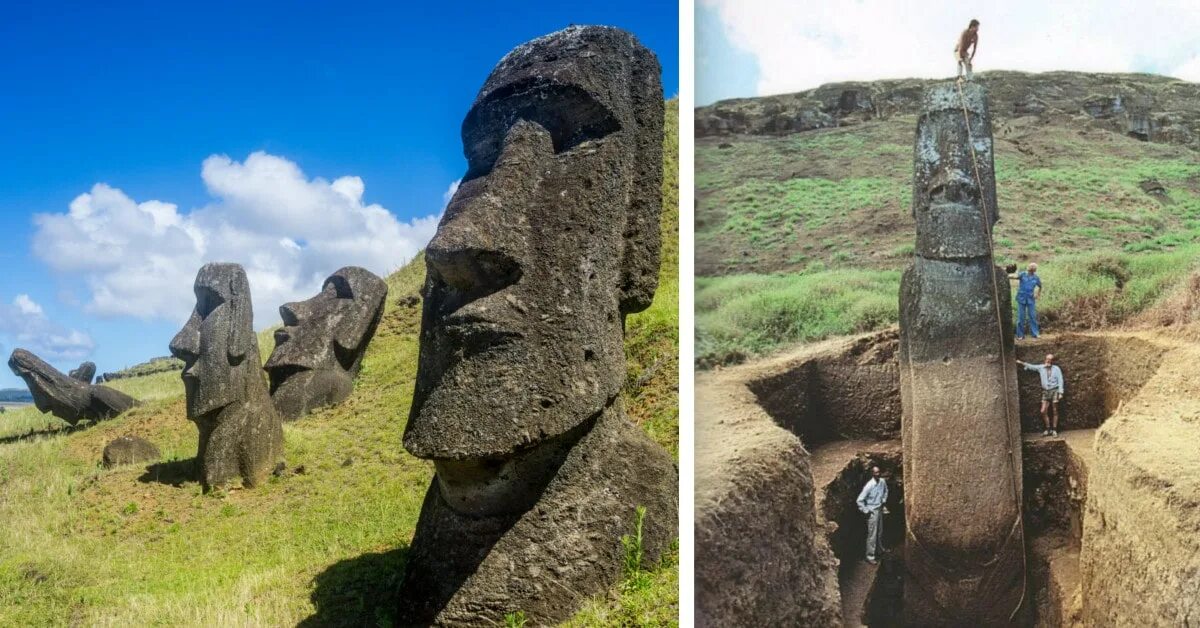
34,152 -> 438,327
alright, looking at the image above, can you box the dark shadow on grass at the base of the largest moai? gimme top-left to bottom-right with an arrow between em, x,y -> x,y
298,545 -> 408,628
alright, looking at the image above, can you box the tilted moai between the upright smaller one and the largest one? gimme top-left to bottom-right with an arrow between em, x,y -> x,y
265,267 -> 388,420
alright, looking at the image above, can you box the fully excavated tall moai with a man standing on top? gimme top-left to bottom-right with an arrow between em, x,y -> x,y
900,83 -> 1025,626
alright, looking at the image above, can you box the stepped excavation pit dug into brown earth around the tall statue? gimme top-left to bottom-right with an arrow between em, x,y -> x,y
746,331 -> 1164,626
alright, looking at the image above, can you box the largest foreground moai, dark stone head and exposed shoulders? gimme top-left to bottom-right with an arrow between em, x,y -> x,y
398,26 -> 678,626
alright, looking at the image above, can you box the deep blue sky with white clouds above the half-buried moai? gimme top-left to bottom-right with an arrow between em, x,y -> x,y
0,0 -> 679,388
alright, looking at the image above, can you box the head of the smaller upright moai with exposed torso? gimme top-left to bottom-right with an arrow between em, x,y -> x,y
170,264 -> 259,419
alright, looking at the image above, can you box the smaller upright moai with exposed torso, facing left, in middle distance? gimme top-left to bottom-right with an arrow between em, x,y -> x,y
170,264 -> 283,491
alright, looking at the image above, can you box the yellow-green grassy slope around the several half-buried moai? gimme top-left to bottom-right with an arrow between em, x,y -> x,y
0,101 -> 678,626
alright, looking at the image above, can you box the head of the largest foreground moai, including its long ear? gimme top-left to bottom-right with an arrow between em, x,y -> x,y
404,26 -> 664,480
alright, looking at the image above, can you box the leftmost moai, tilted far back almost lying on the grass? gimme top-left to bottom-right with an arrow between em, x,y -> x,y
8,349 -> 137,425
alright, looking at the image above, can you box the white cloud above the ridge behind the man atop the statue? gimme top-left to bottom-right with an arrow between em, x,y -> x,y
701,0 -> 1200,95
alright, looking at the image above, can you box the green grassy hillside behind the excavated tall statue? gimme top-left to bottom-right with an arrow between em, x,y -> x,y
696,99 -> 1200,366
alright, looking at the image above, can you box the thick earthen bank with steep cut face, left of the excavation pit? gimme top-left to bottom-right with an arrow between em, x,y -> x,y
695,360 -> 841,627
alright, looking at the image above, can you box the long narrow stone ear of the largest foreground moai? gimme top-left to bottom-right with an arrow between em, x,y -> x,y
620,46 -> 664,313
